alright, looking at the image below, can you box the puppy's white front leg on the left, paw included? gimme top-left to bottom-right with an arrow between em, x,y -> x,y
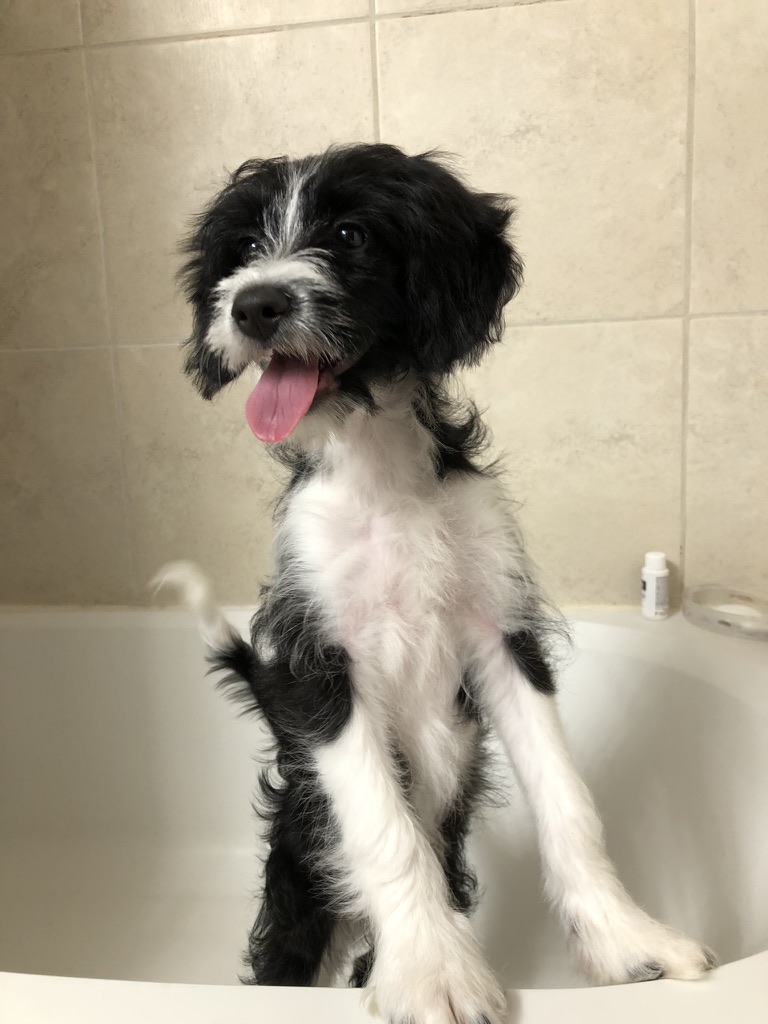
315,697 -> 505,1024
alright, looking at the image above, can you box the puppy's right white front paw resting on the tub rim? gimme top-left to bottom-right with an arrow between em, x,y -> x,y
572,907 -> 718,985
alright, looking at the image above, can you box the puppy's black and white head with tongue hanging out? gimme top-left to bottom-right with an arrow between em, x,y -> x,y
181,145 -> 522,442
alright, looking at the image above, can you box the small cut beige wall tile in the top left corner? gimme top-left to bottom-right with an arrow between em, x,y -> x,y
0,0 -> 82,53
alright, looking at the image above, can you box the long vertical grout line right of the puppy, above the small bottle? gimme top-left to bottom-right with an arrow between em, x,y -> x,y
680,0 -> 696,587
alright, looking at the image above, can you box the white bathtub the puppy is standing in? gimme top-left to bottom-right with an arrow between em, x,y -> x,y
0,611 -> 768,1024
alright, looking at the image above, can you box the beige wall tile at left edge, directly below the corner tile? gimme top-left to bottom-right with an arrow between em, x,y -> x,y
0,52 -> 106,348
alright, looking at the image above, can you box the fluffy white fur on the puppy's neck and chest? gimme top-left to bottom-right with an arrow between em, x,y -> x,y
278,387 -> 536,696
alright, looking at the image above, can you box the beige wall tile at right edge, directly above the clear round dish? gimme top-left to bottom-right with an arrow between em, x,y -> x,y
685,316 -> 768,597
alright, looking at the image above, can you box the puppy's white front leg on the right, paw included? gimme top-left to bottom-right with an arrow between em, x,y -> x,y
474,633 -> 716,984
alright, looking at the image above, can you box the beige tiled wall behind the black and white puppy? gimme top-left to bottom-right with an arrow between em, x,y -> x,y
0,0 -> 768,604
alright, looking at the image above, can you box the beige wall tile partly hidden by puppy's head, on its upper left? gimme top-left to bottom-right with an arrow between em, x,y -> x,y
91,25 -> 373,342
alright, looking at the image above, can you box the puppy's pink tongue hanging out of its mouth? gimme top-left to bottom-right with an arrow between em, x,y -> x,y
246,352 -> 319,444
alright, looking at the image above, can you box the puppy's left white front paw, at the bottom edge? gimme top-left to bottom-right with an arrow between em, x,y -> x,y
365,915 -> 507,1024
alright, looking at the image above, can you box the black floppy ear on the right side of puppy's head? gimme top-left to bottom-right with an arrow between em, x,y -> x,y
406,154 -> 522,373
